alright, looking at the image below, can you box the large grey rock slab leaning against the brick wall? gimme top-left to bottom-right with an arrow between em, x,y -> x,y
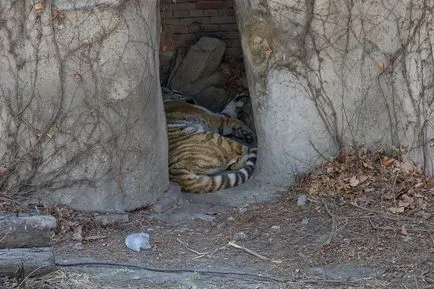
169,37 -> 225,91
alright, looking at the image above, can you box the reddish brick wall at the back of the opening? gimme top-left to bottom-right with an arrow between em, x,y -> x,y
160,0 -> 242,83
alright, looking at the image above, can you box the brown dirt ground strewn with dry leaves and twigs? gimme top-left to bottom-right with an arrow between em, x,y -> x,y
0,150 -> 434,289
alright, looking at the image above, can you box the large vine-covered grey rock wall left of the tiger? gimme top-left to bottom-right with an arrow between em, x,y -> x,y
0,0 -> 168,211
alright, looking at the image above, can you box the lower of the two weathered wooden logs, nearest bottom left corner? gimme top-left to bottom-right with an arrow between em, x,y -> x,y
0,247 -> 56,277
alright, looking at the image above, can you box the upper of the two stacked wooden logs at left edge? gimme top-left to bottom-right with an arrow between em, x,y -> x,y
0,215 -> 57,248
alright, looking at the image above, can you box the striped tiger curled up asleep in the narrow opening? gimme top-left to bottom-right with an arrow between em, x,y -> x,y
164,93 -> 256,193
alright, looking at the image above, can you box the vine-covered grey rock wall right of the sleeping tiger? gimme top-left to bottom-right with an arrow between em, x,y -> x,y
235,0 -> 434,184
